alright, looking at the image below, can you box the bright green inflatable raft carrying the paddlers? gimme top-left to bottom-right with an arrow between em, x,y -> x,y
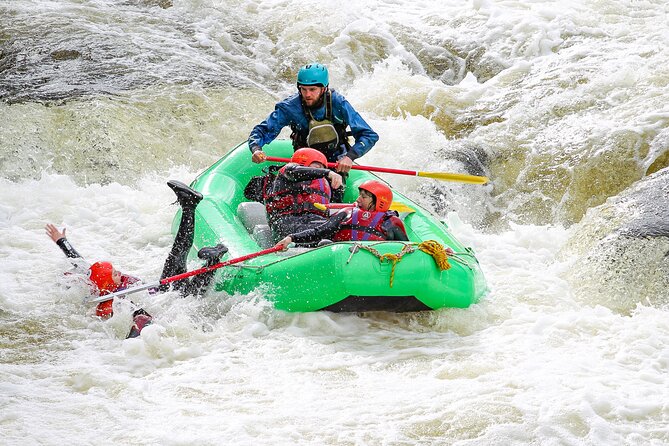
173,140 -> 488,312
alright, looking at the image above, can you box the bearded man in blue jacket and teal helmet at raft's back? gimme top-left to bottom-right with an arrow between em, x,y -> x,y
249,63 -> 379,203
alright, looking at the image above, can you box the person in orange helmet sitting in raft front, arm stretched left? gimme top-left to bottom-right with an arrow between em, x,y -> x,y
275,180 -> 409,250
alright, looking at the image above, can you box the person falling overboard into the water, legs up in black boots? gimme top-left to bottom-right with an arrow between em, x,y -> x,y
45,180 -> 228,338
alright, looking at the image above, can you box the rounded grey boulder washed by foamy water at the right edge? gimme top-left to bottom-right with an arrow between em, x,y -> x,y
561,168 -> 669,314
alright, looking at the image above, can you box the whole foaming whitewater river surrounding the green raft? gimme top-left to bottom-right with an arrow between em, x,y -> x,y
0,0 -> 669,446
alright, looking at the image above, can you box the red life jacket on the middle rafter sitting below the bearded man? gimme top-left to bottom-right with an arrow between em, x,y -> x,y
264,168 -> 332,218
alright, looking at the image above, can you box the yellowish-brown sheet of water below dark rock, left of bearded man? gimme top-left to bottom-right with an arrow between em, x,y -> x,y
0,87 -> 272,184
